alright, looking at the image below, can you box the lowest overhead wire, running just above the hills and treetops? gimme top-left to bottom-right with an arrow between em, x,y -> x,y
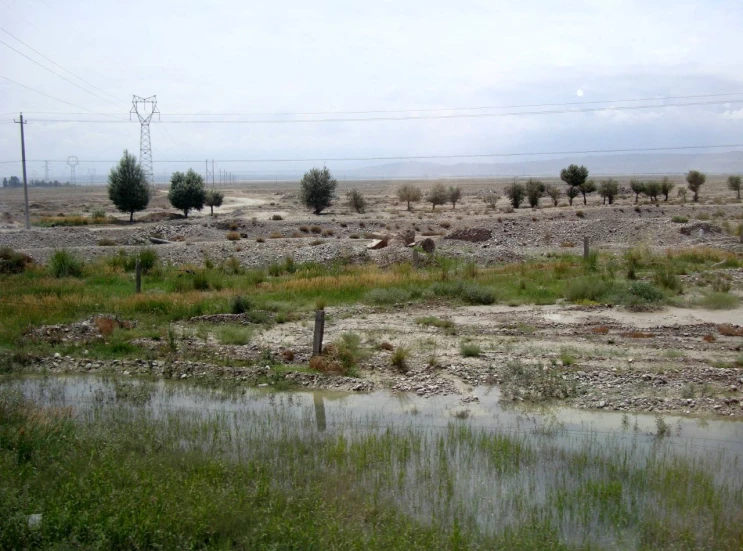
5,143 -> 743,164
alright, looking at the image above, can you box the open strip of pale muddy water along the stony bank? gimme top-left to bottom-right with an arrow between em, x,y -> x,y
13,376 -> 743,458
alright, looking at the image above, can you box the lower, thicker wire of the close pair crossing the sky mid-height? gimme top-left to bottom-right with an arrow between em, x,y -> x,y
26,99 -> 743,124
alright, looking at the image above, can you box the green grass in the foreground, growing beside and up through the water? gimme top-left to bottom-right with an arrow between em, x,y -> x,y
0,384 -> 743,551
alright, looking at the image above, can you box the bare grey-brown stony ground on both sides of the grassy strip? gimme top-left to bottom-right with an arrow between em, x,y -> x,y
0,181 -> 743,417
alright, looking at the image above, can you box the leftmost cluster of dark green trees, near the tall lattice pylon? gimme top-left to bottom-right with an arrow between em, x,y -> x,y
108,151 -> 224,222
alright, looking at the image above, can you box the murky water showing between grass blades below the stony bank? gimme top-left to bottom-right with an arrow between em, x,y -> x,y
7,376 -> 743,549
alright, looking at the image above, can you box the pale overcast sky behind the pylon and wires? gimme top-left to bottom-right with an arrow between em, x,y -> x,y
0,0 -> 743,178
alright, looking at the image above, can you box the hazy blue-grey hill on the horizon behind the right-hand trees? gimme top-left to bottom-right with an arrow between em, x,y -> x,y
344,151 -> 743,179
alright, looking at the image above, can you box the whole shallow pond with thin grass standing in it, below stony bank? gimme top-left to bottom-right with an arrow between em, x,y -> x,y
2,376 -> 743,549
